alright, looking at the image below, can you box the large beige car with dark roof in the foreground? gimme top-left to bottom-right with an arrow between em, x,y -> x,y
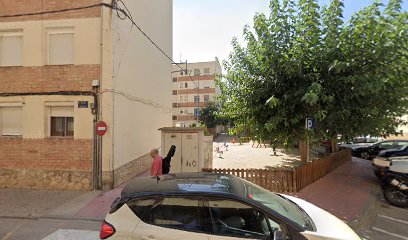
100,173 -> 360,240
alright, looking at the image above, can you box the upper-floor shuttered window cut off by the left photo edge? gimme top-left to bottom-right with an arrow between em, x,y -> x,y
0,31 -> 23,66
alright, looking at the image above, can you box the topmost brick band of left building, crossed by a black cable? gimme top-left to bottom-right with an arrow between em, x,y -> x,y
0,0 -> 100,22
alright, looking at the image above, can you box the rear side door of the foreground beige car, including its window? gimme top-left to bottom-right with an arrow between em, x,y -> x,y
133,197 -> 208,240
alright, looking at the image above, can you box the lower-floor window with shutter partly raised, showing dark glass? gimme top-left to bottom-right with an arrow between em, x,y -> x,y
50,107 -> 74,137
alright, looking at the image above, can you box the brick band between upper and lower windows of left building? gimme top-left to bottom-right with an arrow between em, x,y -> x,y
0,64 -> 100,93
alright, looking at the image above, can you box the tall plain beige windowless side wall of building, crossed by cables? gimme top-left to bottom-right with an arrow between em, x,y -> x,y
108,0 -> 173,169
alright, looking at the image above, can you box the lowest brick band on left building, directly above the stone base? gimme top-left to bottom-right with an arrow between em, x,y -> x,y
0,137 -> 93,171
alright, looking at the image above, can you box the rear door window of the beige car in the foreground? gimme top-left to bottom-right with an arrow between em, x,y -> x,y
144,197 -> 206,232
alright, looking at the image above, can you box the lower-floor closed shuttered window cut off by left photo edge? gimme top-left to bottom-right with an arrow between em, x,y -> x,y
0,107 -> 23,136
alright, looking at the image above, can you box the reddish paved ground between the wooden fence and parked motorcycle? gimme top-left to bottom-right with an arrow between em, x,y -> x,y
298,158 -> 408,240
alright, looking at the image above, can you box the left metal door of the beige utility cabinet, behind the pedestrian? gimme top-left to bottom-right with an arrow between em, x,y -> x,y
162,133 -> 182,173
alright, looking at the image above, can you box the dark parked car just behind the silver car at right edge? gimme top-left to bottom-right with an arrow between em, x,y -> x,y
351,139 -> 408,160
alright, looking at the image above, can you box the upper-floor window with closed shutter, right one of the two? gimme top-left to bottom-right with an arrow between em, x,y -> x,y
47,28 -> 74,65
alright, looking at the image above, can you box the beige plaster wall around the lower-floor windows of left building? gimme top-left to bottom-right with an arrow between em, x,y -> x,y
0,96 -> 93,139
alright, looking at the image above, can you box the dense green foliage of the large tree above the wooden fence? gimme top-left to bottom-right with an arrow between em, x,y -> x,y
218,0 -> 408,142
